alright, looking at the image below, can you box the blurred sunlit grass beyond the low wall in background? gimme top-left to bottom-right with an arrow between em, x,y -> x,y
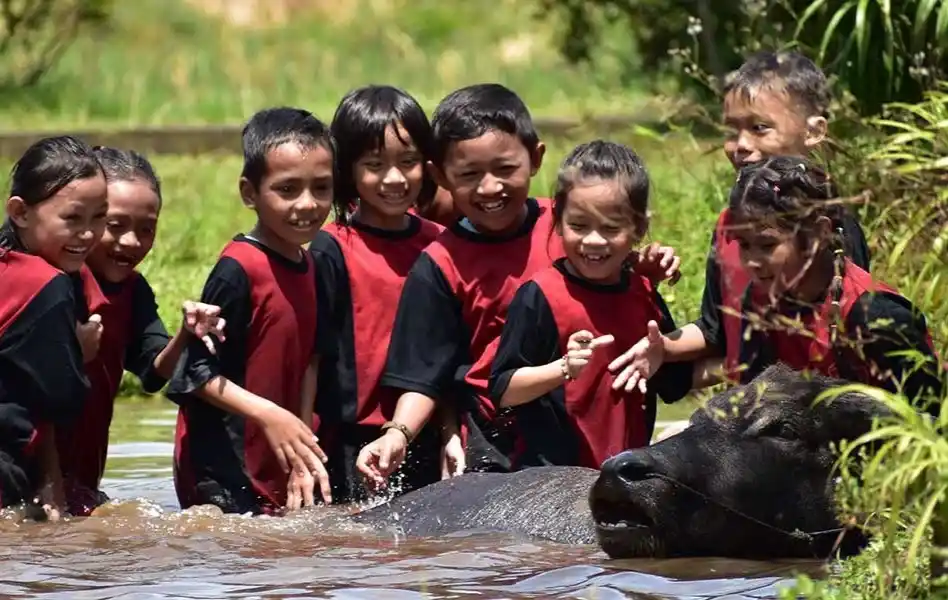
0,0 -> 664,130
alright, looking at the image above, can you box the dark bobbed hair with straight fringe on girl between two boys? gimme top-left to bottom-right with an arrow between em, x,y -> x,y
330,85 -> 438,223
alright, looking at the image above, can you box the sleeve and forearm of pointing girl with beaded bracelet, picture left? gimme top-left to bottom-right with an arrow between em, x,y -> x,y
489,281 -> 567,407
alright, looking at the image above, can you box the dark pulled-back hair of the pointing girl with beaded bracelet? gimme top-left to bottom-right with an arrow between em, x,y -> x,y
553,140 -> 650,237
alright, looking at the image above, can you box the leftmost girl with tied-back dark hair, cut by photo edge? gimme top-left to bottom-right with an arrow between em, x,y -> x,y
0,136 -> 108,518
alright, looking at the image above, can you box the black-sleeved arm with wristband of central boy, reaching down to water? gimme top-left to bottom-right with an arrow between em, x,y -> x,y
357,251 -> 468,485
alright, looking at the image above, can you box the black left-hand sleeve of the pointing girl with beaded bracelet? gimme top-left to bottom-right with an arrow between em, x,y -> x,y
489,281 -> 561,406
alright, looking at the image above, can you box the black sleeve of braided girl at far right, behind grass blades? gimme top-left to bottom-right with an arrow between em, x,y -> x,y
847,293 -> 942,406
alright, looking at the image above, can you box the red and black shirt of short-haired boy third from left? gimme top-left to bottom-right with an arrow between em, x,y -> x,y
167,235 -> 316,513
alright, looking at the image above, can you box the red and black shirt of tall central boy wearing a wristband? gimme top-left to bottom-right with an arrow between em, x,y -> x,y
381,198 -> 563,468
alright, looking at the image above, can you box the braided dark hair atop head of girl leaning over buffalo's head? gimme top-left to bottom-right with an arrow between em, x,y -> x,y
730,156 -> 844,244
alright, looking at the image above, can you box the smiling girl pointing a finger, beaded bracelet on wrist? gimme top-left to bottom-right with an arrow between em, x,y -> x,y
490,140 -> 691,469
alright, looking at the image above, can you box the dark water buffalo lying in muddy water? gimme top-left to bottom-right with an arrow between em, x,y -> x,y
355,365 -> 883,559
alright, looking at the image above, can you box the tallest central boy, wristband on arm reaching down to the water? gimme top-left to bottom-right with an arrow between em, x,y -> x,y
358,84 -> 680,485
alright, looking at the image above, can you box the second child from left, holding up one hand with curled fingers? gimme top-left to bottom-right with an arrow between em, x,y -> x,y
56,146 -> 223,516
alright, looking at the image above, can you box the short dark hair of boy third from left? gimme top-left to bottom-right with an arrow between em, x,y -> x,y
241,106 -> 336,187
